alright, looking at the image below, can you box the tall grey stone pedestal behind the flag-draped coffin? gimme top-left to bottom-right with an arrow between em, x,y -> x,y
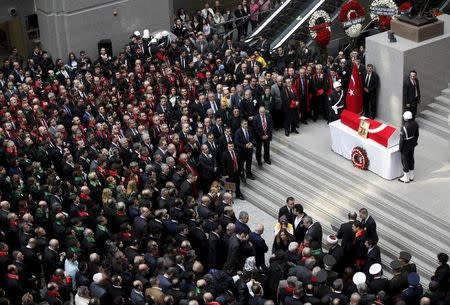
366,15 -> 450,127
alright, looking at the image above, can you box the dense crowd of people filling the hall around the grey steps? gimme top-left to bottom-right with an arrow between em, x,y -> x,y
0,0 -> 450,305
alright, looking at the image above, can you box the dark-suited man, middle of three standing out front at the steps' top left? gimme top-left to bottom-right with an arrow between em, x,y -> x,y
234,120 -> 255,183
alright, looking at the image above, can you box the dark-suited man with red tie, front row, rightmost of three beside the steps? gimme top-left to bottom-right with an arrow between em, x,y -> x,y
253,106 -> 273,166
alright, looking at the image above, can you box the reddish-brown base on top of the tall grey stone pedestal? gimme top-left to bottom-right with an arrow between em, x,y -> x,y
391,19 -> 444,42
